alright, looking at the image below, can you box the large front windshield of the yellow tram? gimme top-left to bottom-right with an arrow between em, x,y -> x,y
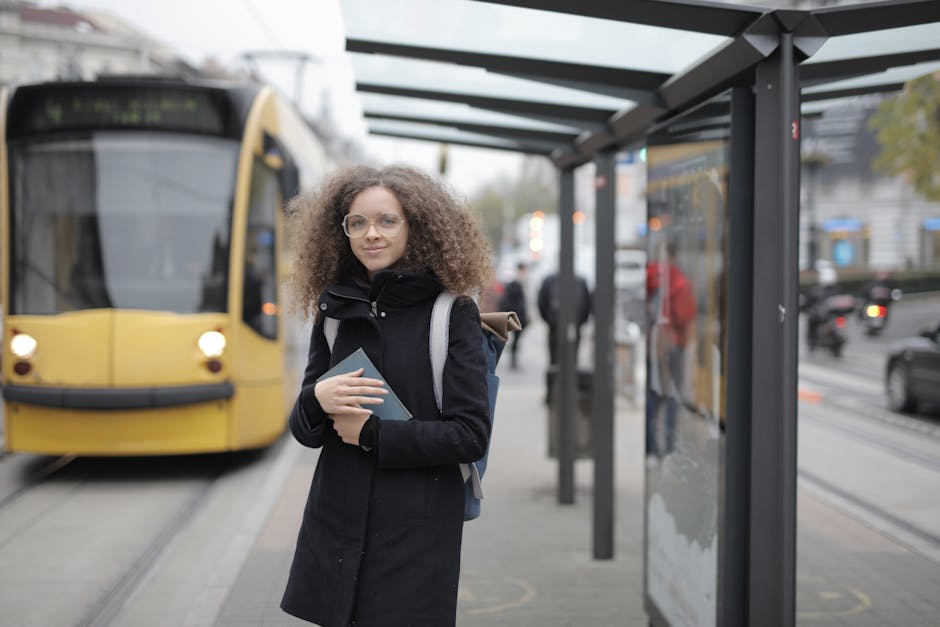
10,132 -> 239,314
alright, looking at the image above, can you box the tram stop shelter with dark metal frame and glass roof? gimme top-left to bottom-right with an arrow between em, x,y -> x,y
342,0 -> 940,625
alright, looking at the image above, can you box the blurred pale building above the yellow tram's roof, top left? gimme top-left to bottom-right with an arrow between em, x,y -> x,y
0,0 -> 199,84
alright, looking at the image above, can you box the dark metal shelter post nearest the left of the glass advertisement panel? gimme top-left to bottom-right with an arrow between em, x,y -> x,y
591,150 -> 617,559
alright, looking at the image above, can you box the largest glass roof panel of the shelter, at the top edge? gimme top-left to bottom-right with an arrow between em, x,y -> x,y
340,0 -> 729,74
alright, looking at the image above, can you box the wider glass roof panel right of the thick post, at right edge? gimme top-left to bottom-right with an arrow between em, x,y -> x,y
804,23 -> 940,65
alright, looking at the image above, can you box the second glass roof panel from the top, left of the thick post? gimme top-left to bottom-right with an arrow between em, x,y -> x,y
349,53 -> 631,111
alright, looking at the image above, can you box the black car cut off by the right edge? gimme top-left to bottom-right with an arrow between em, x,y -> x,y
885,324 -> 940,411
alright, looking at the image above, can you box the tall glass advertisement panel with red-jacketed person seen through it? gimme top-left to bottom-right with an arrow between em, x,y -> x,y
645,137 -> 729,627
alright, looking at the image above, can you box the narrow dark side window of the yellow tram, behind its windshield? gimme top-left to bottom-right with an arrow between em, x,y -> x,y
242,159 -> 281,339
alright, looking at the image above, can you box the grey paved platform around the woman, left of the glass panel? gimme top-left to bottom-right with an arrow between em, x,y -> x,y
216,328 -> 646,627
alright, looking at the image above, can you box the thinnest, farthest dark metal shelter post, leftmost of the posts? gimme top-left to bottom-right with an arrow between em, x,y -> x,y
555,168 -> 577,503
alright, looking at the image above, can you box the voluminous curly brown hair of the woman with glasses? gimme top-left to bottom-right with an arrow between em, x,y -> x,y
287,165 -> 490,316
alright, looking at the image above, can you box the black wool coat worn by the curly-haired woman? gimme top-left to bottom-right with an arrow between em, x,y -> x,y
281,270 -> 490,627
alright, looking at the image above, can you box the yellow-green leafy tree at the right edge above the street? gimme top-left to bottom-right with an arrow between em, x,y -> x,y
868,72 -> 940,201
